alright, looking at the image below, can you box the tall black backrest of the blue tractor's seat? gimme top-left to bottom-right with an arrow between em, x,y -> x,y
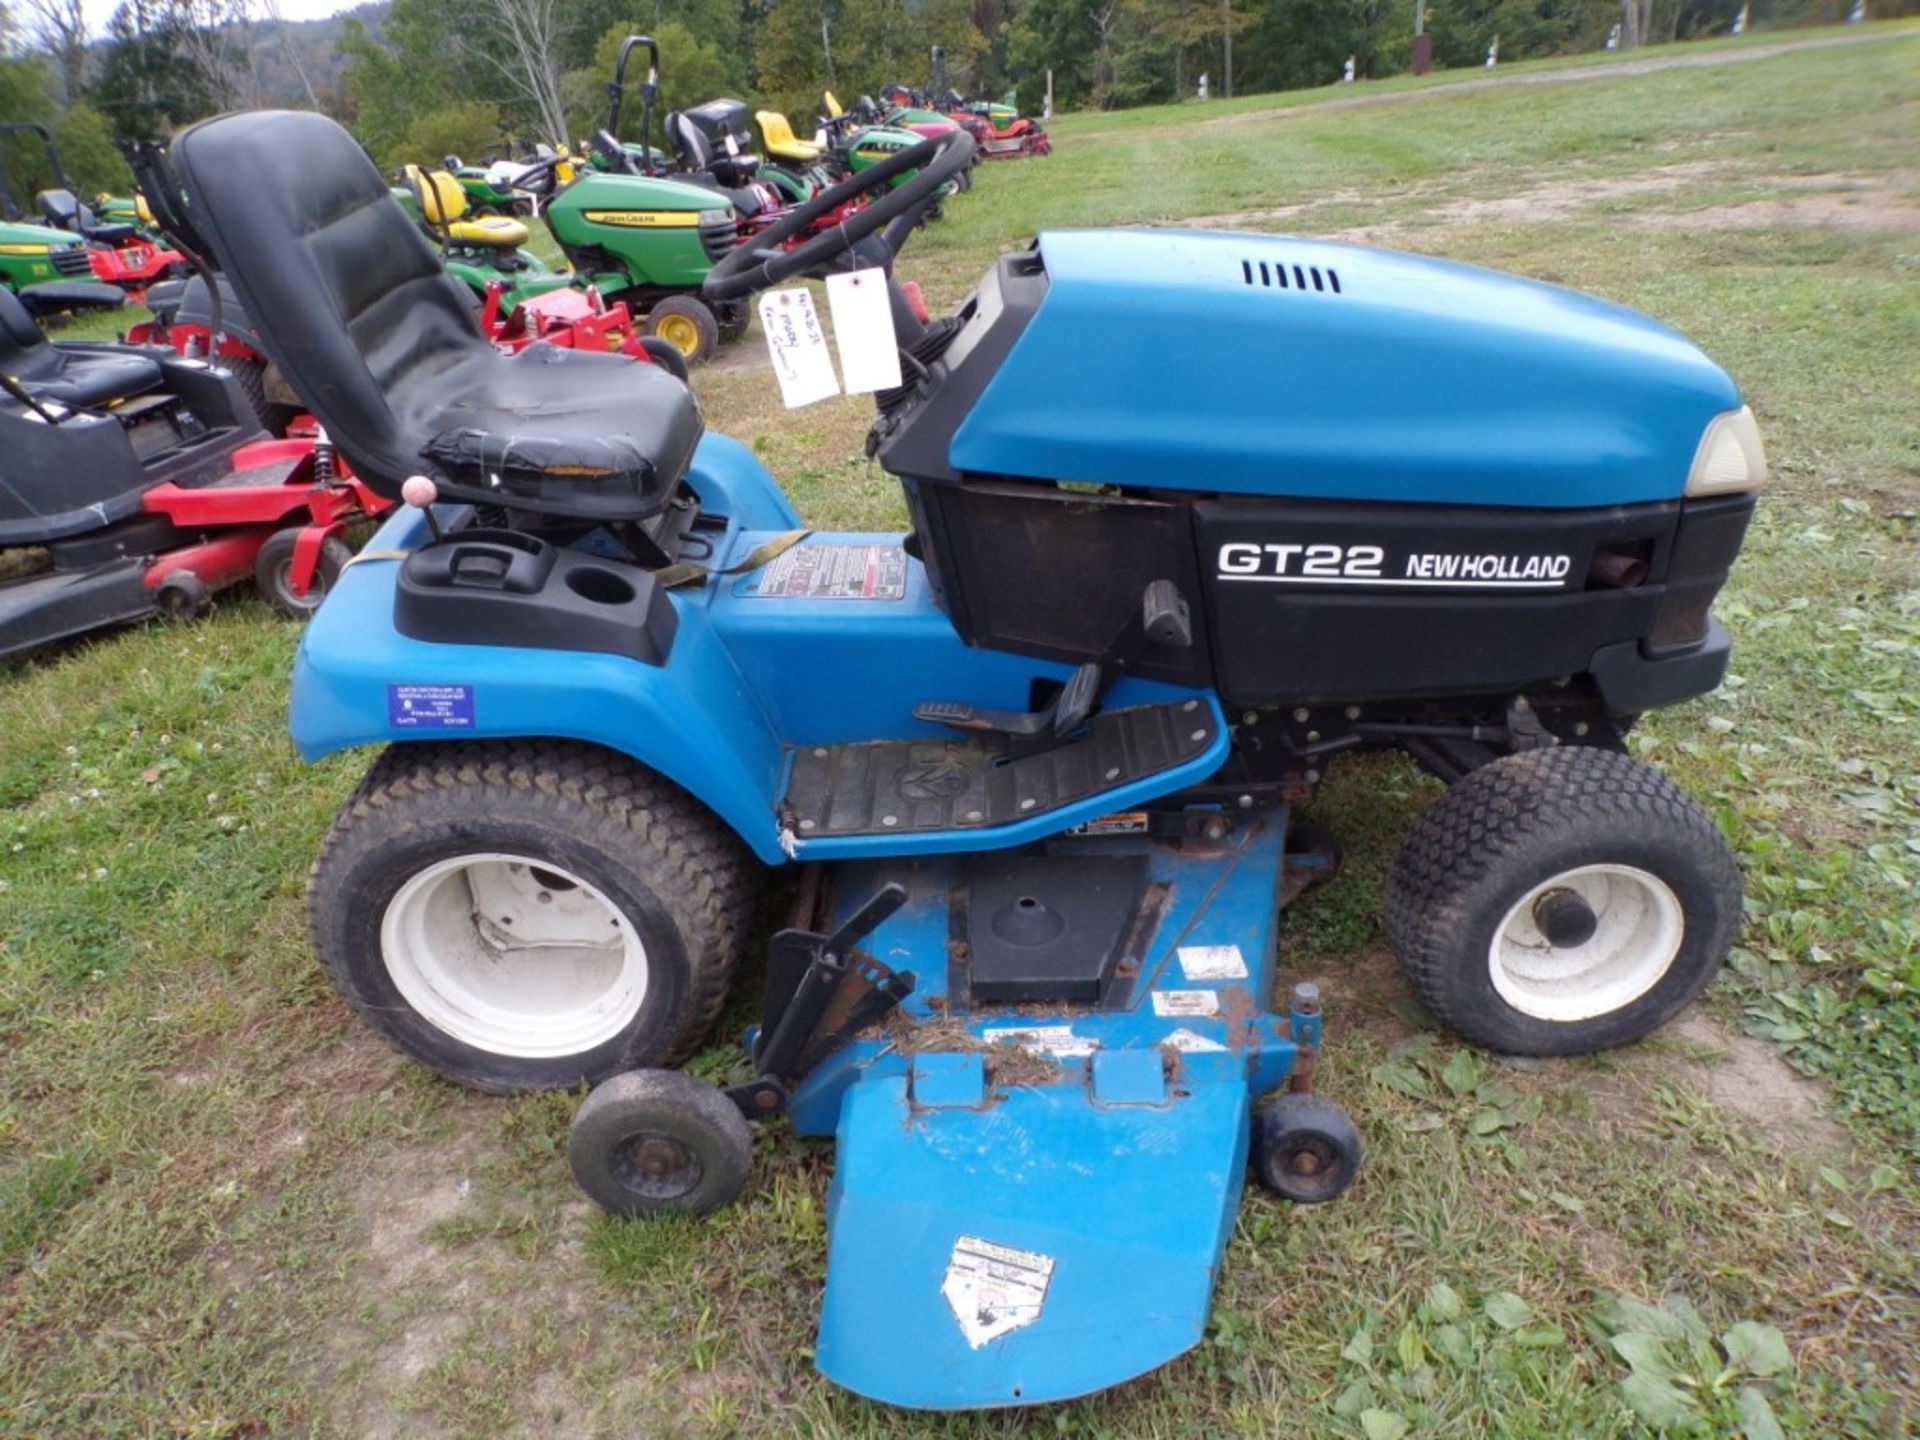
173,109 -> 492,493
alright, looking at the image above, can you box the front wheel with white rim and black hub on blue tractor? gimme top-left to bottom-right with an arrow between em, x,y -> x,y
1386,745 -> 1740,1056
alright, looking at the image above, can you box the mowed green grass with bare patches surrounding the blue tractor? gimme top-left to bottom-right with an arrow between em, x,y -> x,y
0,29 -> 1920,1440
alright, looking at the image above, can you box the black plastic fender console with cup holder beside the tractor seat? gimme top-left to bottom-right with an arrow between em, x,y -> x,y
394,530 -> 678,664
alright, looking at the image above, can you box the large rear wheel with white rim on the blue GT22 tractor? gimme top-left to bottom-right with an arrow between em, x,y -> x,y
307,739 -> 751,1092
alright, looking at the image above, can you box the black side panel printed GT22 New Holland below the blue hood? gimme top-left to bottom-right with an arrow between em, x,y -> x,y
1194,499 -> 1704,705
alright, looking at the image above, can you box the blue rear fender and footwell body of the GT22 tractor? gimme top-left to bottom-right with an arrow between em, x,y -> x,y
290,436 -> 1229,864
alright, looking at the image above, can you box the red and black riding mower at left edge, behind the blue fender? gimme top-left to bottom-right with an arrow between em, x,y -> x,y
0,278 -> 390,655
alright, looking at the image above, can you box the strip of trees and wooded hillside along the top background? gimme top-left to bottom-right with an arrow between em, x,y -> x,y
0,0 -> 1920,194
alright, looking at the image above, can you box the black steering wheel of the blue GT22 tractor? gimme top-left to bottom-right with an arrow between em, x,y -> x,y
701,129 -> 973,301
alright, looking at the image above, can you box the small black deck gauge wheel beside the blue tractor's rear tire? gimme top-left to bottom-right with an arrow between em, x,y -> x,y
566,1069 -> 753,1215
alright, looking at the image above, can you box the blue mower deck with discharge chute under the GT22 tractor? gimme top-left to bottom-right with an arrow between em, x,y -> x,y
791,814 -> 1317,1409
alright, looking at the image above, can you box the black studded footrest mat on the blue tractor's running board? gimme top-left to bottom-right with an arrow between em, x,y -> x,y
787,701 -> 1213,839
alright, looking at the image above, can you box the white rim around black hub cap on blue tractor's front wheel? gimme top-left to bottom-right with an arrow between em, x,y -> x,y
1486,866 -> 1686,1023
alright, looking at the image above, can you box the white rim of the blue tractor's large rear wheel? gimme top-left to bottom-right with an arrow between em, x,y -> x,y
380,852 -> 647,1060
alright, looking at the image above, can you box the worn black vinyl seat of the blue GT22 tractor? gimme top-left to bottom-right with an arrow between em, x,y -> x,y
173,109 -> 703,520
